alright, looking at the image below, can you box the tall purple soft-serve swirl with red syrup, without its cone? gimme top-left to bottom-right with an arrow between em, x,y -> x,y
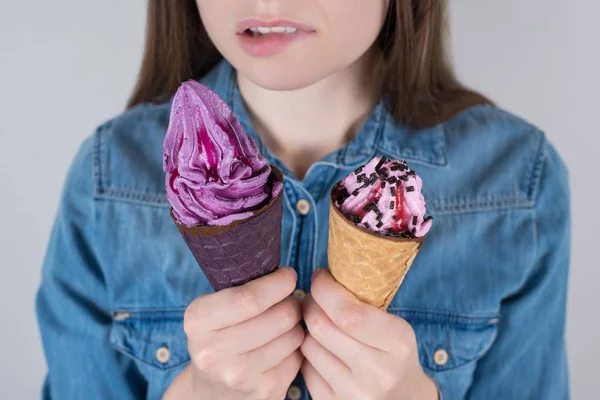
163,81 -> 283,227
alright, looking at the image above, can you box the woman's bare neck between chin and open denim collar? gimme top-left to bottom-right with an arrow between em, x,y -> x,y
237,47 -> 379,178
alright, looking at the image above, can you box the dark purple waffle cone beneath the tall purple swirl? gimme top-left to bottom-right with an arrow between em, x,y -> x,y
171,166 -> 283,291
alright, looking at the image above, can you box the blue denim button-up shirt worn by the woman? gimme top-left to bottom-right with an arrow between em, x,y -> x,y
37,61 -> 570,400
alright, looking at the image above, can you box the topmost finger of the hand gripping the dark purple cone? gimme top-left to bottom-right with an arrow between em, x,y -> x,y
186,268 -> 298,330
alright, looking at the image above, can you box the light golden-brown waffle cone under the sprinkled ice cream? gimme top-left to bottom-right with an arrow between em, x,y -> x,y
327,201 -> 424,310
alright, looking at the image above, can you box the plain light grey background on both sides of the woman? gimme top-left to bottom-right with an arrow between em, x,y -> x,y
0,0 -> 600,399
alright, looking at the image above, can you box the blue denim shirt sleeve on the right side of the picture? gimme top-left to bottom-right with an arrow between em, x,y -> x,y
467,139 -> 570,399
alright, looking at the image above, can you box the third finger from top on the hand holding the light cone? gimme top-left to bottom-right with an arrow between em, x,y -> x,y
300,334 -> 353,398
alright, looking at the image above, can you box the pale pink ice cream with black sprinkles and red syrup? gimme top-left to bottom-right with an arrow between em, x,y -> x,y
332,157 -> 433,238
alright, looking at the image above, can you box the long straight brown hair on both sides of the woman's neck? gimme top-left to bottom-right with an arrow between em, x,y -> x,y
128,0 -> 489,128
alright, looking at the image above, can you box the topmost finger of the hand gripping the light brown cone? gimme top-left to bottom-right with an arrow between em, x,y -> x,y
310,270 -> 399,351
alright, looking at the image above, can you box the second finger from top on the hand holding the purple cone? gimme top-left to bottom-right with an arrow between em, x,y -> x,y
215,296 -> 302,354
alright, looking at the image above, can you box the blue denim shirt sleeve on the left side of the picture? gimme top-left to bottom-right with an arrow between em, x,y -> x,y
36,135 -> 147,400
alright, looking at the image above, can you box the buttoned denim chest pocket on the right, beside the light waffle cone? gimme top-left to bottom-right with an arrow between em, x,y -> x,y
388,309 -> 498,400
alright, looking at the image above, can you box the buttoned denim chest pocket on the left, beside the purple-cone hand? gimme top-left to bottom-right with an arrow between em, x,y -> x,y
110,308 -> 190,398
